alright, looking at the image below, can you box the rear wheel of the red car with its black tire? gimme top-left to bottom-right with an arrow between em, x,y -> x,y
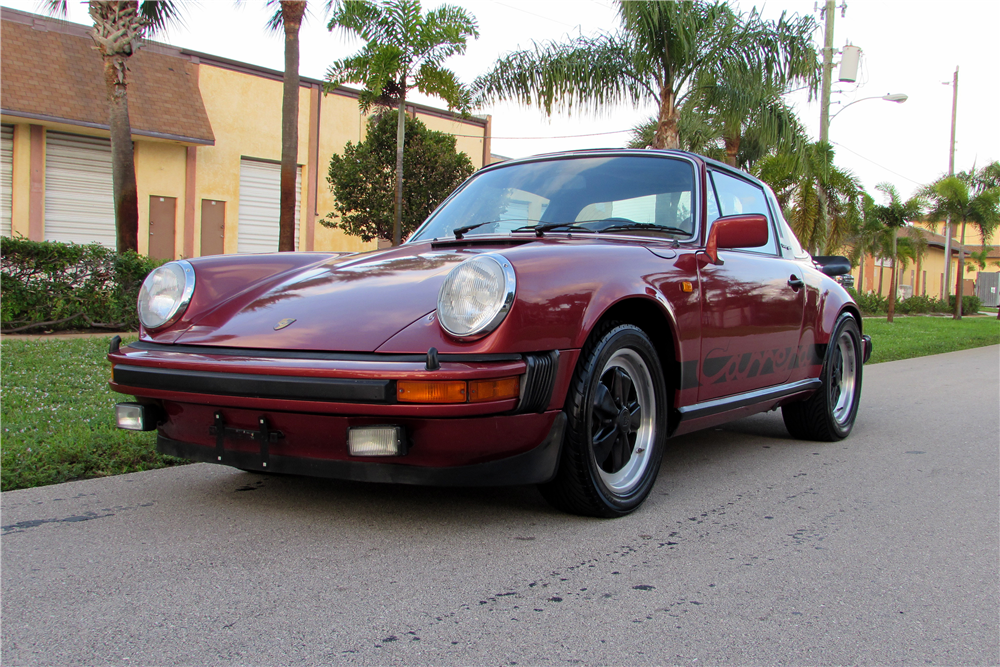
781,313 -> 863,442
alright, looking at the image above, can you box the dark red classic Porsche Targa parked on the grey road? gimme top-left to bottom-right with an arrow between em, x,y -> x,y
108,150 -> 871,517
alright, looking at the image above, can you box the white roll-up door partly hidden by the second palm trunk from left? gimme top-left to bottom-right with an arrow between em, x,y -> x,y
236,158 -> 302,252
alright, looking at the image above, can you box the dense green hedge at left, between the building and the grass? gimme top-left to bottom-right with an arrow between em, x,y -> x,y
0,237 -> 163,333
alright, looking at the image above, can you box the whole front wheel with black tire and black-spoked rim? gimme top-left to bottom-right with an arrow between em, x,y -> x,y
539,323 -> 667,518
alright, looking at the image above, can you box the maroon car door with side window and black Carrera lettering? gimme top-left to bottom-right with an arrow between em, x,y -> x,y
698,170 -> 805,402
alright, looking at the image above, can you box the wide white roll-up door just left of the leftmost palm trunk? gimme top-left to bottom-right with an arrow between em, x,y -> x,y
45,132 -> 116,248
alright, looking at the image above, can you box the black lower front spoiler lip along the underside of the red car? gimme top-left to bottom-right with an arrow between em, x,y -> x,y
156,413 -> 566,486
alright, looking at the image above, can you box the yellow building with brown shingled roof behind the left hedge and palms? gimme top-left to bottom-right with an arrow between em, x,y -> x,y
0,8 -> 490,259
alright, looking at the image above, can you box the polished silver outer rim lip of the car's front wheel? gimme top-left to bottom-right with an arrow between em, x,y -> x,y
590,348 -> 657,495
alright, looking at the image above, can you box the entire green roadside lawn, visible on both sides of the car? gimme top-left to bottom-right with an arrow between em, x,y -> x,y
0,316 -> 1000,491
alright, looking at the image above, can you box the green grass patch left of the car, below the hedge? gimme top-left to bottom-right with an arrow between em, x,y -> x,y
0,336 -> 181,491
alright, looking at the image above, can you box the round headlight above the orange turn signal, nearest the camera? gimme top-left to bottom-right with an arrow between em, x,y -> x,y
438,255 -> 515,338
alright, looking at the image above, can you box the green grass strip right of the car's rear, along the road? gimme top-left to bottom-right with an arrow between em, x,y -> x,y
863,315 -> 1000,364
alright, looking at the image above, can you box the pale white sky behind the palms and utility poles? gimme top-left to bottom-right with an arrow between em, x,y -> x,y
0,0 -> 1000,198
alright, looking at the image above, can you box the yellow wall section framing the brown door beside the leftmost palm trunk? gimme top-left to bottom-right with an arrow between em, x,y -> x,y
134,141 -> 187,257
